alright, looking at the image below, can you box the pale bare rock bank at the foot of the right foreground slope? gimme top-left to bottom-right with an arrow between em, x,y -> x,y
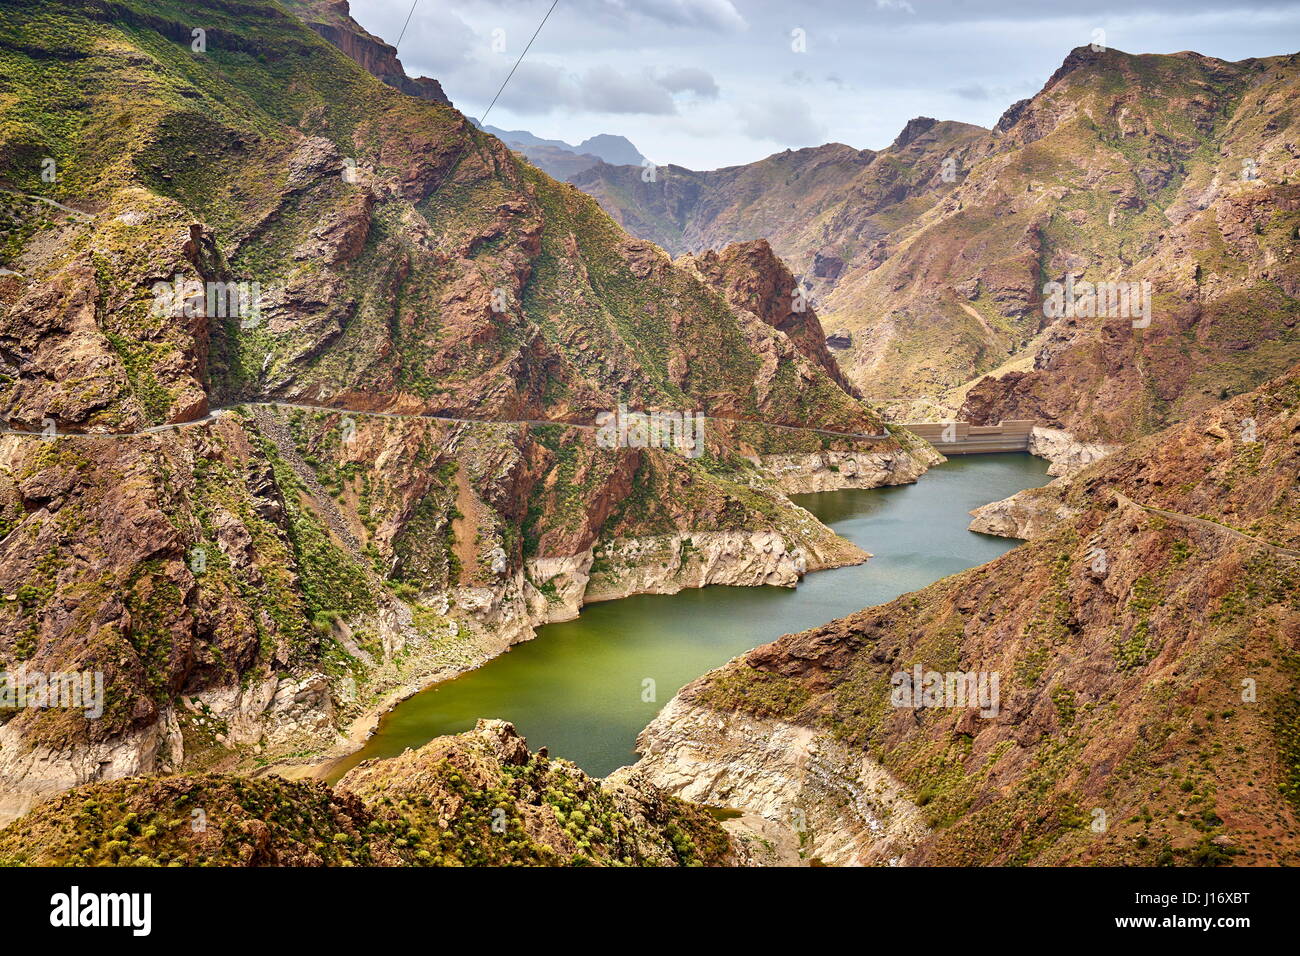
636,697 -> 927,866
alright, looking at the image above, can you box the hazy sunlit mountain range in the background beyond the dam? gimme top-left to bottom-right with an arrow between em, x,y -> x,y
572,48 -> 1300,444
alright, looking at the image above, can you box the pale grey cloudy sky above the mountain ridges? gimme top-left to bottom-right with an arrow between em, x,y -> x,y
351,0 -> 1300,169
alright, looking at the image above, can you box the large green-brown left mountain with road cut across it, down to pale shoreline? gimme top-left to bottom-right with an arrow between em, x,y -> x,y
0,0 -> 941,818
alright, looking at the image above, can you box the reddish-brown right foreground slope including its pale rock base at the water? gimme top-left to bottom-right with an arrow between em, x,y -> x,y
637,368 -> 1300,865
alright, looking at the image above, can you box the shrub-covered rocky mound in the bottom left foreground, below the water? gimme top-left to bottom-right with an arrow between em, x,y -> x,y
0,721 -> 736,866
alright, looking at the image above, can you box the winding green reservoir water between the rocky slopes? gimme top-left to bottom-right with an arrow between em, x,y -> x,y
330,454 -> 1049,780
